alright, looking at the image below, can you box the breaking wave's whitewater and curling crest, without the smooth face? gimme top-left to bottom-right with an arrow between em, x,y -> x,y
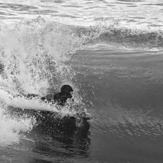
0,17 -> 163,145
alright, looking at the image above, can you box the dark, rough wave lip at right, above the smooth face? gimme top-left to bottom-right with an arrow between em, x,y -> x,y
97,26 -> 163,49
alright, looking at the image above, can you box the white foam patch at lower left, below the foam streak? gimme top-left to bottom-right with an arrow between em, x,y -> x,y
0,103 -> 35,147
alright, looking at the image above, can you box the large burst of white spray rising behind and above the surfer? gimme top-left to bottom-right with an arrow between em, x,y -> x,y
0,18 -> 88,94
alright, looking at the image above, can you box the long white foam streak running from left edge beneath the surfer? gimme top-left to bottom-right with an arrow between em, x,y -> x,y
0,88 -> 82,117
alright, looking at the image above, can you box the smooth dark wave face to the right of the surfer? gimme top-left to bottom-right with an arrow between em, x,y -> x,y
70,45 -> 163,162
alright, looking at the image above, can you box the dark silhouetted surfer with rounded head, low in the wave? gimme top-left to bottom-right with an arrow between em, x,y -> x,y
26,85 -> 73,106
